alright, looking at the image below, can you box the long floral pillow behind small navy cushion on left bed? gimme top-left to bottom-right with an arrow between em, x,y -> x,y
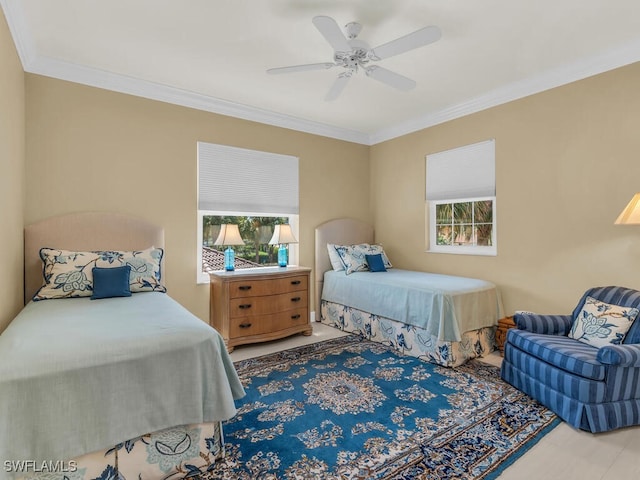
33,247 -> 166,301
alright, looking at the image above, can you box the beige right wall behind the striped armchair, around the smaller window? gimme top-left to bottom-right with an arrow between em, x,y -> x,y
370,63 -> 640,313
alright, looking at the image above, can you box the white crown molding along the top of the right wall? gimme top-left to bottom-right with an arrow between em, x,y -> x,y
370,41 -> 640,145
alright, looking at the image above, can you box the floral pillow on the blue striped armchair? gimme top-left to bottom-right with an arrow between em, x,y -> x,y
569,296 -> 639,348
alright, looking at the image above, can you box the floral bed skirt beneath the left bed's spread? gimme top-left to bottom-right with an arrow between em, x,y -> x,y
16,422 -> 224,480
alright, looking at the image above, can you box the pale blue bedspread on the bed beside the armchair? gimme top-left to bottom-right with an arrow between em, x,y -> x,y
322,268 -> 502,342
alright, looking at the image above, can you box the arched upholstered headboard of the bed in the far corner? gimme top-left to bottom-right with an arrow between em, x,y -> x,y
314,218 -> 373,313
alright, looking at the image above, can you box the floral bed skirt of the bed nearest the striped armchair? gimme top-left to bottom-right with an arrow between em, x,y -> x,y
320,300 -> 496,367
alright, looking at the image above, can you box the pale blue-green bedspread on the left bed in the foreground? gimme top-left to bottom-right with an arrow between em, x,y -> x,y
0,292 -> 244,478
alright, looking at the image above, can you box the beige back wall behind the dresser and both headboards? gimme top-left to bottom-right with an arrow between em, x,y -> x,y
25,74 -> 372,319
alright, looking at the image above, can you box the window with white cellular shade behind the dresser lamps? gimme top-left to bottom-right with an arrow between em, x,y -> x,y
197,142 -> 299,283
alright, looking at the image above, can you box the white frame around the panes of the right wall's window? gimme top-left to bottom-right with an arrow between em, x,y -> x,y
427,196 -> 498,256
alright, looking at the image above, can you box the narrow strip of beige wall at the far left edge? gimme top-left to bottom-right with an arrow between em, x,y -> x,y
0,9 -> 25,333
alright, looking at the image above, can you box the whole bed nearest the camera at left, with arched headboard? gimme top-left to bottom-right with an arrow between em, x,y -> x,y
0,212 -> 248,480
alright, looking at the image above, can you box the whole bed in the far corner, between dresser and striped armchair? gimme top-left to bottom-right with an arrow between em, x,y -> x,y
314,218 -> 503,367
